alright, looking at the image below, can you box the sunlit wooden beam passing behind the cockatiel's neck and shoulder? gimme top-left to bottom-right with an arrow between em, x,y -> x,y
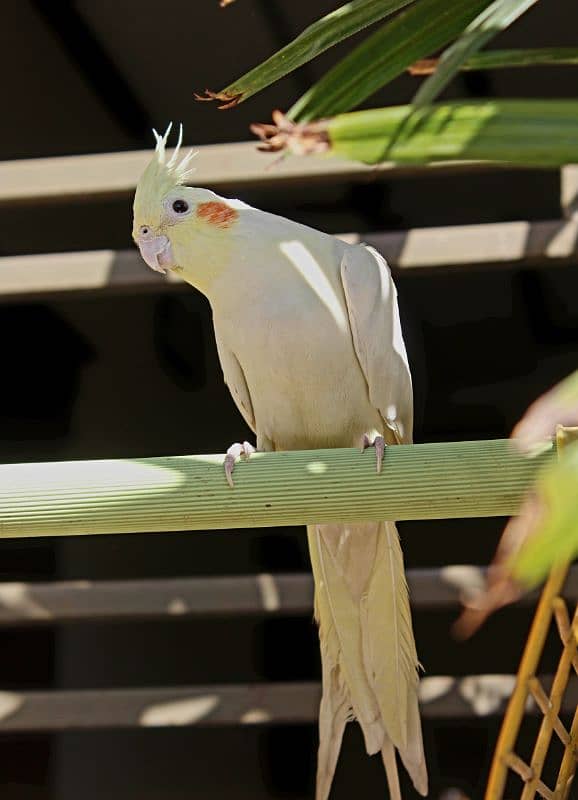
0,218 -> 578,300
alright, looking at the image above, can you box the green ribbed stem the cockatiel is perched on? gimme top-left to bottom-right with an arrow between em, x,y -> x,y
0,439 -> 555,538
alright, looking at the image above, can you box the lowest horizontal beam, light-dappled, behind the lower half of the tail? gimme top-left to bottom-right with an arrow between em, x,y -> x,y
0,675 -> 578,733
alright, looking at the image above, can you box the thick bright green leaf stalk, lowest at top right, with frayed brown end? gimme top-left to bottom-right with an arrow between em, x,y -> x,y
320,100 -> 578,167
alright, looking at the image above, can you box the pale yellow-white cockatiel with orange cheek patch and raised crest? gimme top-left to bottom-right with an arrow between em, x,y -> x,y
133,128 -> 427,800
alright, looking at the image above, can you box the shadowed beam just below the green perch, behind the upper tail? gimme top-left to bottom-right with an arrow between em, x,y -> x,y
0,564 -> 578,627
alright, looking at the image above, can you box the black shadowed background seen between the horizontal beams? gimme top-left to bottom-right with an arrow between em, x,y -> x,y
0,0 -> 578,800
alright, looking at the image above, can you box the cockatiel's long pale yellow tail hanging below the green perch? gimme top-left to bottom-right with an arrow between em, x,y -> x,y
308,522 -> 427,800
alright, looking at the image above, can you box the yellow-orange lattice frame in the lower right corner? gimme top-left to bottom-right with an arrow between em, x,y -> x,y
485,426 -> 578,800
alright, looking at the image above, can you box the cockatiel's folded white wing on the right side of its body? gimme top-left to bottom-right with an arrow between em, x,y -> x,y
341,245 -> 413,443
